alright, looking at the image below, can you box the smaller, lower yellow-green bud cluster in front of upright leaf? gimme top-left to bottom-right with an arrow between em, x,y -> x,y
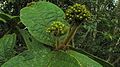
46,21 -> 66,36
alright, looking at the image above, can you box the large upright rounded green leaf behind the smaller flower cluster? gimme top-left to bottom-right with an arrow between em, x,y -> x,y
20,1 -> 68,45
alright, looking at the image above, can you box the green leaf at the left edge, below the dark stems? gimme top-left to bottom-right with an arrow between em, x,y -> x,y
0,34 -> 16,65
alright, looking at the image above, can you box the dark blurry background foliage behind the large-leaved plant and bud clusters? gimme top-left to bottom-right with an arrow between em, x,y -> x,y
0,0 -> 120,67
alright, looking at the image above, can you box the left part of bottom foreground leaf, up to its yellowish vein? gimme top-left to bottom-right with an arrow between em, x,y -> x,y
2,50 -> 80,67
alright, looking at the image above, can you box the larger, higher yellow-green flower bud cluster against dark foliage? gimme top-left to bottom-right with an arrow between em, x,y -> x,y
65,4 -> 91,24
